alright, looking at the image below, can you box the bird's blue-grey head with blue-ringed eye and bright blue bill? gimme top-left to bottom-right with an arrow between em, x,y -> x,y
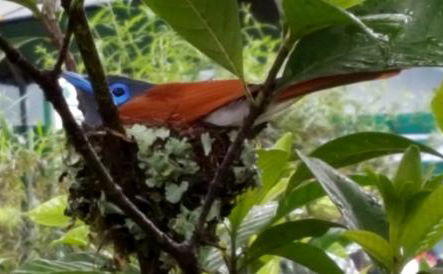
62,71 -> 153,106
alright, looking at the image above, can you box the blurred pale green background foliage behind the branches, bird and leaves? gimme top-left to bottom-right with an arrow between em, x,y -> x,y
0,0 -> 442,273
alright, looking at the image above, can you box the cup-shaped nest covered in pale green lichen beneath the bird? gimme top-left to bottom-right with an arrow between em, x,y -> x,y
67,125 -> 256,270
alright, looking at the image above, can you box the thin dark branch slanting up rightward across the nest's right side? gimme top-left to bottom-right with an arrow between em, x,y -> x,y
193,33 -> 294,246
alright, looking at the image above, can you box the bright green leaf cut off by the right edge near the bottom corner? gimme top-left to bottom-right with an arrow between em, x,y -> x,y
401,186 -> 443,258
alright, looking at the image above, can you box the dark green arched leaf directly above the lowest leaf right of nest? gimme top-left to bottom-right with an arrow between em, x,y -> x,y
246,219 -> 341,262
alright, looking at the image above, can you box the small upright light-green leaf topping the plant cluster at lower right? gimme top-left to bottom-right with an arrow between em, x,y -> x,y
393,145 -> 423,199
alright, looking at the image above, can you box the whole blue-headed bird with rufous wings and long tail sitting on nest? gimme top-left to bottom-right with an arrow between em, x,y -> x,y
61,70 -> 400,130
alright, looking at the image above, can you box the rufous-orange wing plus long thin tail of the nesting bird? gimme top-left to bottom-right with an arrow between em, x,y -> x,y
119,70 -> 399,127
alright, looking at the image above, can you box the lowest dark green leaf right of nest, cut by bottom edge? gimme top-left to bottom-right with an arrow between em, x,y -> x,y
269,243 -> 343,274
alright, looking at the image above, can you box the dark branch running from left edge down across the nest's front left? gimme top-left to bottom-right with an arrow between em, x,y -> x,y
0,35 -> 199,274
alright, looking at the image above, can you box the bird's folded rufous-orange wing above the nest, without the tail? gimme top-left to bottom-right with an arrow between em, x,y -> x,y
119,80 -> 244,127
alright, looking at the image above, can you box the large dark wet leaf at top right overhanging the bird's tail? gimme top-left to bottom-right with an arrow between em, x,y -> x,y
284,0 -> 443,84
